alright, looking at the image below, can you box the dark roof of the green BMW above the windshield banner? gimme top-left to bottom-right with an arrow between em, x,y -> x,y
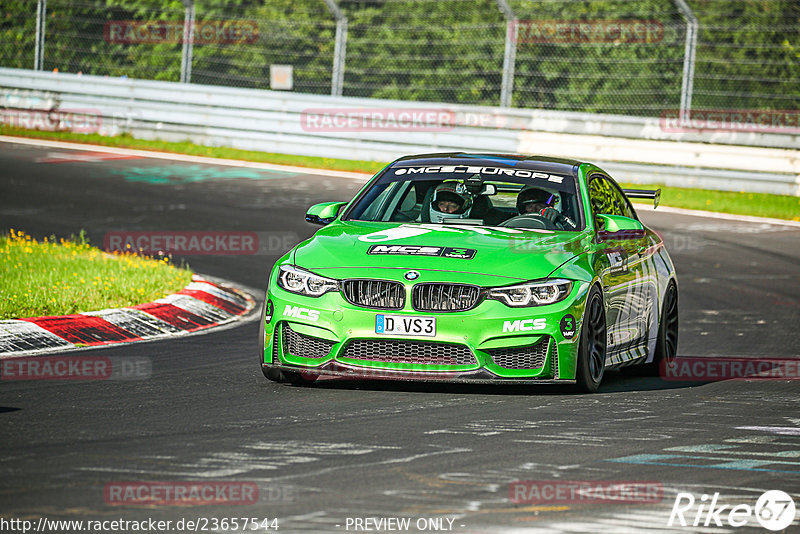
391,152 -> 584,176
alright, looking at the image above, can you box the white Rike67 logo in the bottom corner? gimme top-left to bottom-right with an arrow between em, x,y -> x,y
667,490 -> 796,532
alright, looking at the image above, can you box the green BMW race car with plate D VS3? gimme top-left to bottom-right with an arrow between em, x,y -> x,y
259,153 -> 678,392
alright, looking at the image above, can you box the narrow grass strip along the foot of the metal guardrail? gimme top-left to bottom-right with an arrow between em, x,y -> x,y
0,126 -> 800,221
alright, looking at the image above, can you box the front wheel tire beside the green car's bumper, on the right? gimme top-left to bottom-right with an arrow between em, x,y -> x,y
575,286 -> 606,393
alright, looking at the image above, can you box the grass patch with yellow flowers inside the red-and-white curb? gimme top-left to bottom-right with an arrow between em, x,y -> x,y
0,230 -> 192,319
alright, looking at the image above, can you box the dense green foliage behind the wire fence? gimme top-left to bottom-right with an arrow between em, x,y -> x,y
0,0 -> 800,116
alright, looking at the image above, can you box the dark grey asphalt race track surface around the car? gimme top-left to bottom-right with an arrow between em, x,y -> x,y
0,143 -> 800,533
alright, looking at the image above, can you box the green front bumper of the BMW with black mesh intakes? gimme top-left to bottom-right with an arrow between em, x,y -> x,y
261,274 -> 588,384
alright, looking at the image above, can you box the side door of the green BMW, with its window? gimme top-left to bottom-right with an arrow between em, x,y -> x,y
589,173 -> 651,363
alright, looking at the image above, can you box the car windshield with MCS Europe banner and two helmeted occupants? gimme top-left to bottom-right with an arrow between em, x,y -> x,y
347,165 -> 584,231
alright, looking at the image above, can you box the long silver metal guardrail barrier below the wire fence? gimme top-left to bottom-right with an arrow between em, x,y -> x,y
0,68 -> 800,195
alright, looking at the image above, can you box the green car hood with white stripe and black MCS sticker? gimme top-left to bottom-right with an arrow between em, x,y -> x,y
293,221 -> 587,284
